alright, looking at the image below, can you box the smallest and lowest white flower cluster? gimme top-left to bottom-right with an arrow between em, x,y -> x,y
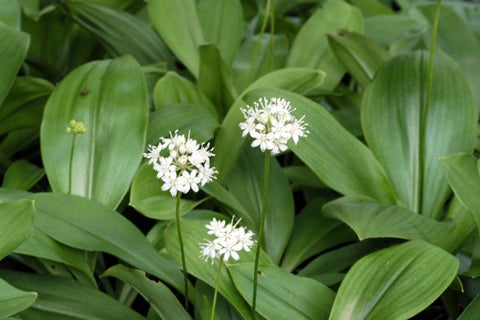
200,218 -> 255,264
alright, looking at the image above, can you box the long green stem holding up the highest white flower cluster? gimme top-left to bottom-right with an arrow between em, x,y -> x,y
252,150 -> 270,319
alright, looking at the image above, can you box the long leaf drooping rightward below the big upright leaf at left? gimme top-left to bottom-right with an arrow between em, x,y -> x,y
31,193 -> 183,291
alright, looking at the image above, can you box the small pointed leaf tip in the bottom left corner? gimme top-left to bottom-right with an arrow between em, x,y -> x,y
0,279 -> 38,319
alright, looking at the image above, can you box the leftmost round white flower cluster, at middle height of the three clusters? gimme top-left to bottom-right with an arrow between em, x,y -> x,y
143,130 -> 218,197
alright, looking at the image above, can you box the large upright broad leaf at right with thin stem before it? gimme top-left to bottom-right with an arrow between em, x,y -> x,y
362,51 -> 476,219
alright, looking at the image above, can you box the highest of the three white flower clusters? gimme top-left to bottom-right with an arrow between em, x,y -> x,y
240,98 -> 308,154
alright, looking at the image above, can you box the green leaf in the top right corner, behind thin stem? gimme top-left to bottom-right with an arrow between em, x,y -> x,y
418,5 -> 480,110
